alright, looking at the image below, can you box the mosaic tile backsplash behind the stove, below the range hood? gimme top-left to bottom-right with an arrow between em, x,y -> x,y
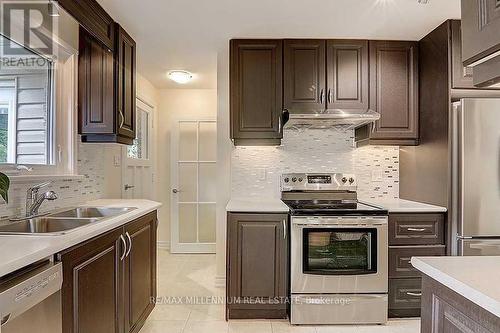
231,130 -> 399,199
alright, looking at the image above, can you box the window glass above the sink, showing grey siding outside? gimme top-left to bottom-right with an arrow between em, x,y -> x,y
0,35 -> 55,165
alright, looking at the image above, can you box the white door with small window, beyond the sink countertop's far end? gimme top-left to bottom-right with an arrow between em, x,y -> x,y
122,99 -> 154,200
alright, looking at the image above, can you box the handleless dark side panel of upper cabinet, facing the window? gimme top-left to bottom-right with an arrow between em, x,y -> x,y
78,29 -> 114,134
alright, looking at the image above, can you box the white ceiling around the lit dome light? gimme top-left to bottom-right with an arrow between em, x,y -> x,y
98,0 -> 460,88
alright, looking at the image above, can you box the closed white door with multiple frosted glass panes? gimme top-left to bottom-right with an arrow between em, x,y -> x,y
171,120 -> 217,253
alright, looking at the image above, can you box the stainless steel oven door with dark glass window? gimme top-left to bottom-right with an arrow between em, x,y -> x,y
291,216 -> 388,294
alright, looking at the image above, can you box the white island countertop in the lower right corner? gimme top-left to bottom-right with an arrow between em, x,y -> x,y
411,256 -> 500,318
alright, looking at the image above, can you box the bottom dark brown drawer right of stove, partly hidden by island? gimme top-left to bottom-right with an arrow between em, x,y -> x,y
389,278 -> 422,317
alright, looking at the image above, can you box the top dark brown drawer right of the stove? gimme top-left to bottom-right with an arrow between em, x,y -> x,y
389,214 -> 444,245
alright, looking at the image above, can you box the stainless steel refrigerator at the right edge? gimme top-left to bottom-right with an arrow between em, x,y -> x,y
449,98 -> 500,256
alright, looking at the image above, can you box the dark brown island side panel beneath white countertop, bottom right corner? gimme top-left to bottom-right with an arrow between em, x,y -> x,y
421,275 -> 500,333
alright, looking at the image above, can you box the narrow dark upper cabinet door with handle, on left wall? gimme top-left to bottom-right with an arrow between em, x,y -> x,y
115,24 -> 136,140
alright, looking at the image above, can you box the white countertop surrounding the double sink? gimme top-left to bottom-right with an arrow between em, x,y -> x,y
0,199 -> 161,277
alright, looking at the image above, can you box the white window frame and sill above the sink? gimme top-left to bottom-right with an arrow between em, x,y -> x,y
0,44 -> 81,180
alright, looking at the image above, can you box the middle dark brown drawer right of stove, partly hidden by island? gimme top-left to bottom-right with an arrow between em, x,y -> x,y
389,245 -> 445,278
